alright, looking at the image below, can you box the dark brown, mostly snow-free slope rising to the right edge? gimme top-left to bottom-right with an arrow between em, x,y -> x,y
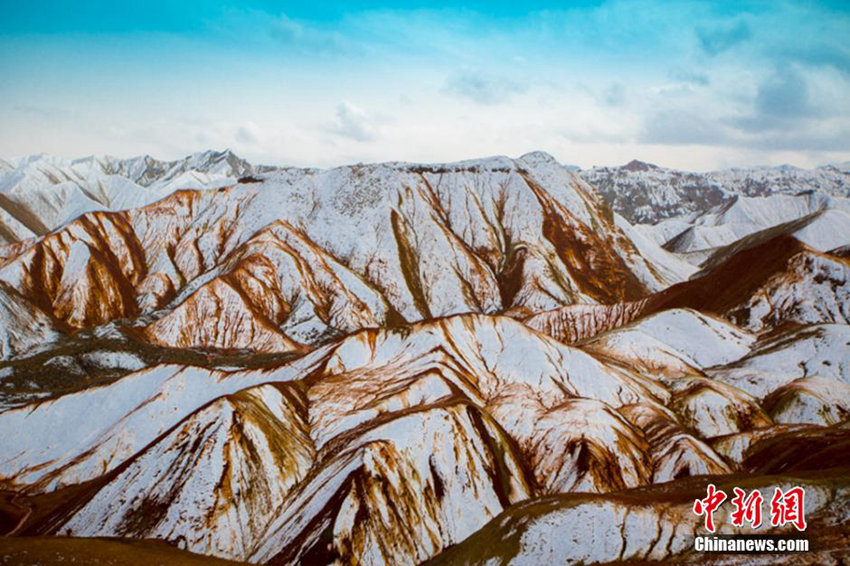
525,234 -> 850,342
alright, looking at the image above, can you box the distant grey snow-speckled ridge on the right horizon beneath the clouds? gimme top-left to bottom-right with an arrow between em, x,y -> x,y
580,160 -> 850,224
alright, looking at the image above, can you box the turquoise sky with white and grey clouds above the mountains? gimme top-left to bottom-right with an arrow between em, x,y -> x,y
0,0 -> 850,171
